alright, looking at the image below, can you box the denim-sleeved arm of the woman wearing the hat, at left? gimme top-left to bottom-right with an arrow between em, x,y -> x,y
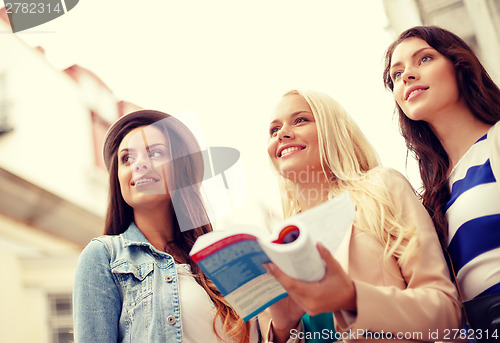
73,240 -> 122,343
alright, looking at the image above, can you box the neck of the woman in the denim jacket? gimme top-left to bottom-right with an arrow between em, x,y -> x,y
134,208 -> 175,251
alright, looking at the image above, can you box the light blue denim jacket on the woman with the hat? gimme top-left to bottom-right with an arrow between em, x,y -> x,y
73,223 -> 182,343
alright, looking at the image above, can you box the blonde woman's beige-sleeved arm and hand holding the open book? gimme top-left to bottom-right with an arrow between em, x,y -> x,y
266,171 -> 461,340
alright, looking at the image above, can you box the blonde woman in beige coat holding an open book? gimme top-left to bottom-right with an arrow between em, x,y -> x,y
267,90 -> 461,342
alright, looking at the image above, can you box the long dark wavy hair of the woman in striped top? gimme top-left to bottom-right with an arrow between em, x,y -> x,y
383,26 -> 500,247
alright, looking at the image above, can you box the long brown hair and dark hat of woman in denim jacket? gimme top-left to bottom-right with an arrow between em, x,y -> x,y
104,110 -> 249,342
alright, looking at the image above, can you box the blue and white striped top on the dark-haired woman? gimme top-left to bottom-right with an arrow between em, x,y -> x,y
446,123 -> 500,301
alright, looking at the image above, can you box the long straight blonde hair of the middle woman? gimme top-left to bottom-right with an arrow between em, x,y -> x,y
279,90 -> 418,262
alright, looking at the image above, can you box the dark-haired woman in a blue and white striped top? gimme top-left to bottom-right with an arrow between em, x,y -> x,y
383,26 -> 500,334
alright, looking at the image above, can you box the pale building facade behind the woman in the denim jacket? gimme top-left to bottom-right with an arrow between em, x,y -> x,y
0,9 -> 138,343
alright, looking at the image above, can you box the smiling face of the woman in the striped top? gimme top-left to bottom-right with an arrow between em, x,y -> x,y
390,37 -> 464,124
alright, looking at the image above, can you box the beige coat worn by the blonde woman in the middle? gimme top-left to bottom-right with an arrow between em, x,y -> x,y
264,168 -> 462,342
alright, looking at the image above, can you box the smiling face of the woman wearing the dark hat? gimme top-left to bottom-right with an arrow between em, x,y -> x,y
118,125 -> 170,209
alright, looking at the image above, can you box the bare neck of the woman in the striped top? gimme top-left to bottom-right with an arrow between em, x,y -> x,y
429,108 -> 491,170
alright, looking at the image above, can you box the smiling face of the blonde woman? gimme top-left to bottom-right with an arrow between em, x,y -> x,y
267,94 -> 321,182
